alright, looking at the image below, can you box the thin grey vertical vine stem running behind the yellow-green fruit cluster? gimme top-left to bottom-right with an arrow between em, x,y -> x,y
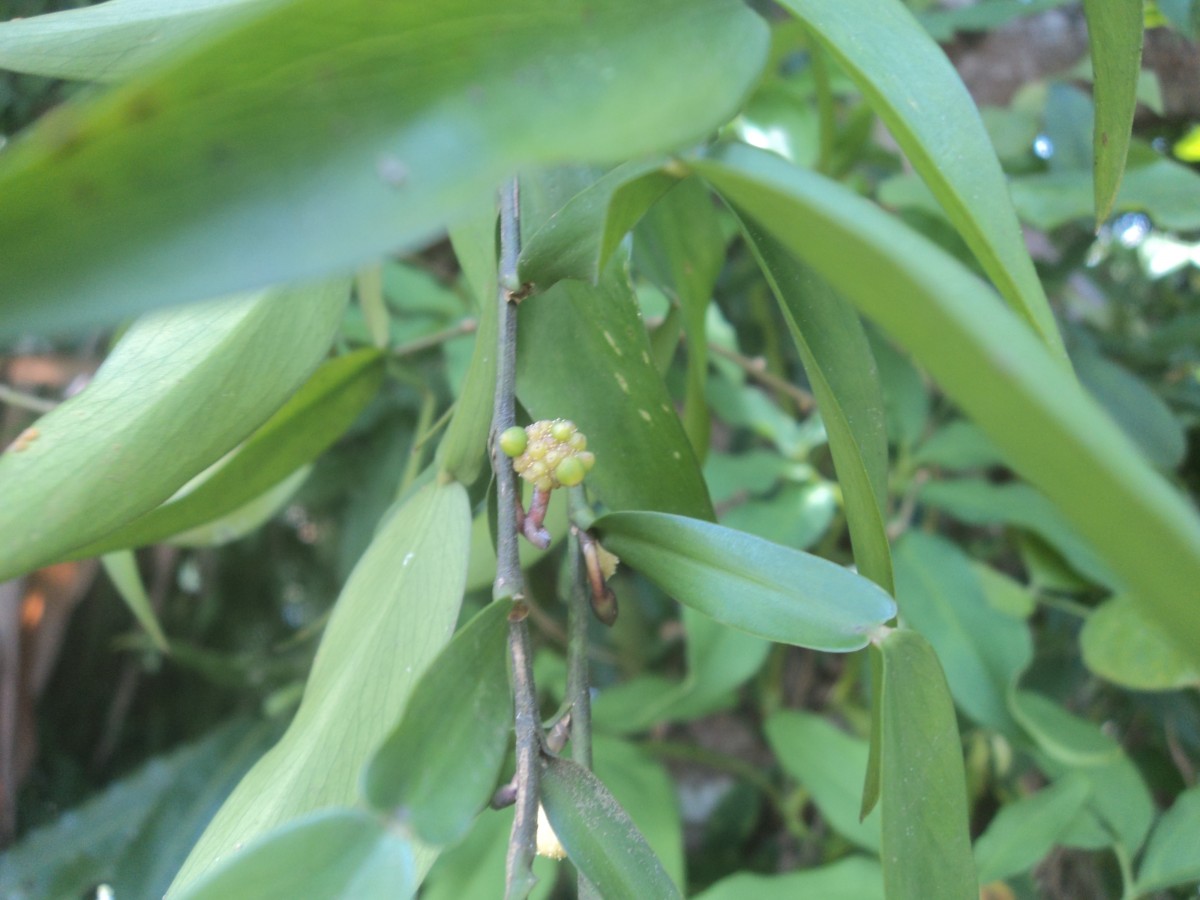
491,179 -> 542,900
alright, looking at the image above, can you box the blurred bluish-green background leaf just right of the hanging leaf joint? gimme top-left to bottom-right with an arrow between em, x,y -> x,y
895,532 -> 1033,736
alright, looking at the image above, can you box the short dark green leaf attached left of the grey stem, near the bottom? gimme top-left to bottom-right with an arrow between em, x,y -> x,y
362,602 -> 512,845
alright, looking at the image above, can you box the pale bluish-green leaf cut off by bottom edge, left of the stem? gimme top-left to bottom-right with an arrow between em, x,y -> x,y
174,809 -> 418,900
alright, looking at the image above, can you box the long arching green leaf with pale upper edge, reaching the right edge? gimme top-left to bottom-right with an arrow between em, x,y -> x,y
692,148 -> 1200,672
